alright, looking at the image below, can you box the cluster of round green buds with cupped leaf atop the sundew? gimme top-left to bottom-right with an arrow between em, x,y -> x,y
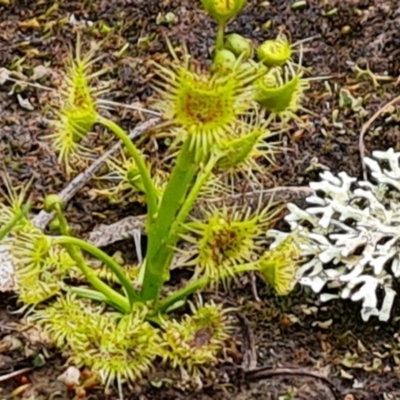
202,0 -> 308,121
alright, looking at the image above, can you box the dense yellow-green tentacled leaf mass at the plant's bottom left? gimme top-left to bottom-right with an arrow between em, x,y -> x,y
30,295 -> 163,387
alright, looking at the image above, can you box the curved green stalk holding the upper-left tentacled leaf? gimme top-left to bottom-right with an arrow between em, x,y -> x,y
97,115 -> 157,225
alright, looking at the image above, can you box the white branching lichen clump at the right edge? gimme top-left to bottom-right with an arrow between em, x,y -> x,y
268,149 -> 400,321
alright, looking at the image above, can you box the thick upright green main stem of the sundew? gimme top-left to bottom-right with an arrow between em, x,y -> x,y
140,139 -> 198,301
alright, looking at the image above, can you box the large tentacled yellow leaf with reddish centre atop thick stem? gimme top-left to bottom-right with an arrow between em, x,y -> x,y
150,51 -> 255,159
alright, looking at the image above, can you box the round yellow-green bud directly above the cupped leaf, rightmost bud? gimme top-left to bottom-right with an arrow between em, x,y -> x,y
257,35 -> 292,67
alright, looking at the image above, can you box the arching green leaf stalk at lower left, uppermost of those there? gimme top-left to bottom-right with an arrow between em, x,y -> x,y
53,236 -> 139,305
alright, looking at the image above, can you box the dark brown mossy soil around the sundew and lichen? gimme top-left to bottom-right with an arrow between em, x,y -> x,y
0,0 -> 400,400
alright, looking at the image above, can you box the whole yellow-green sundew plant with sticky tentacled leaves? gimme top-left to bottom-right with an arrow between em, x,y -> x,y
0,0 -> 308,391
